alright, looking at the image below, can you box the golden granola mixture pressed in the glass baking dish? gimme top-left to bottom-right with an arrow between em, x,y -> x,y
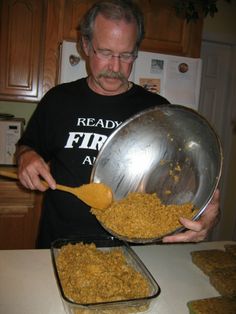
56,243 -> 150,304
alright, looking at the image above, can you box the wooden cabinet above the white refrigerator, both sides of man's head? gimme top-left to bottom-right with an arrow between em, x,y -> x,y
63,0 -> 203,57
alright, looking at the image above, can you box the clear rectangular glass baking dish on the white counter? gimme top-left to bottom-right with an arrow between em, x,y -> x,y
51,236 -> 160,314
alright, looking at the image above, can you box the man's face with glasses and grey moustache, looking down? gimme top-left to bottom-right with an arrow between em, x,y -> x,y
83,15 -> 137,95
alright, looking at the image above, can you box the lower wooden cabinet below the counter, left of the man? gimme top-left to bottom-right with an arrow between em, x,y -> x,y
0,175 -> 42,249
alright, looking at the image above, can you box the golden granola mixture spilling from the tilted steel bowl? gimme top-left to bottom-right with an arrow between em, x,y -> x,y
91,192 -> 196,239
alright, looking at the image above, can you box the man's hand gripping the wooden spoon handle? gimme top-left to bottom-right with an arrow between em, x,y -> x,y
17,146 -> 56,192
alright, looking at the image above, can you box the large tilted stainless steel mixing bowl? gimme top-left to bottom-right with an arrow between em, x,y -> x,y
91,105 -> 223,242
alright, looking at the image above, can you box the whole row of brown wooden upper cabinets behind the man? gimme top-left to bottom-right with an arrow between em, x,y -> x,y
0,0 -> 203,102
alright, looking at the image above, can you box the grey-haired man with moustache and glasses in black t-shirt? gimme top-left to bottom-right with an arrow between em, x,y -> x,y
17,0 -> 219,248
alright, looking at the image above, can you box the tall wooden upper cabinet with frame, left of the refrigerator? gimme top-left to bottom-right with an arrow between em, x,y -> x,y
0,0 -> 64,102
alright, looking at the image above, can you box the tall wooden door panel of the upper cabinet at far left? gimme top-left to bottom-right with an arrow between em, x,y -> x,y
0,0 -> 46,101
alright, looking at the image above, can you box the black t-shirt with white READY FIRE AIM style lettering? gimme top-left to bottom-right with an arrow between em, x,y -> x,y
19,78 -> 168,248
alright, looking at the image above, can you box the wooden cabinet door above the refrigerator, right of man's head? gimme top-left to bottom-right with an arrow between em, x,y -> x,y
137,0 -> 203,57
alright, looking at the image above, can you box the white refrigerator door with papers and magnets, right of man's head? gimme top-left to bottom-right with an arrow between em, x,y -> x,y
133,51 -> 202,110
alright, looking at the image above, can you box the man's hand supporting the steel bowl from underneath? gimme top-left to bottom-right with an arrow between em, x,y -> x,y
162,190 -> 220,243
